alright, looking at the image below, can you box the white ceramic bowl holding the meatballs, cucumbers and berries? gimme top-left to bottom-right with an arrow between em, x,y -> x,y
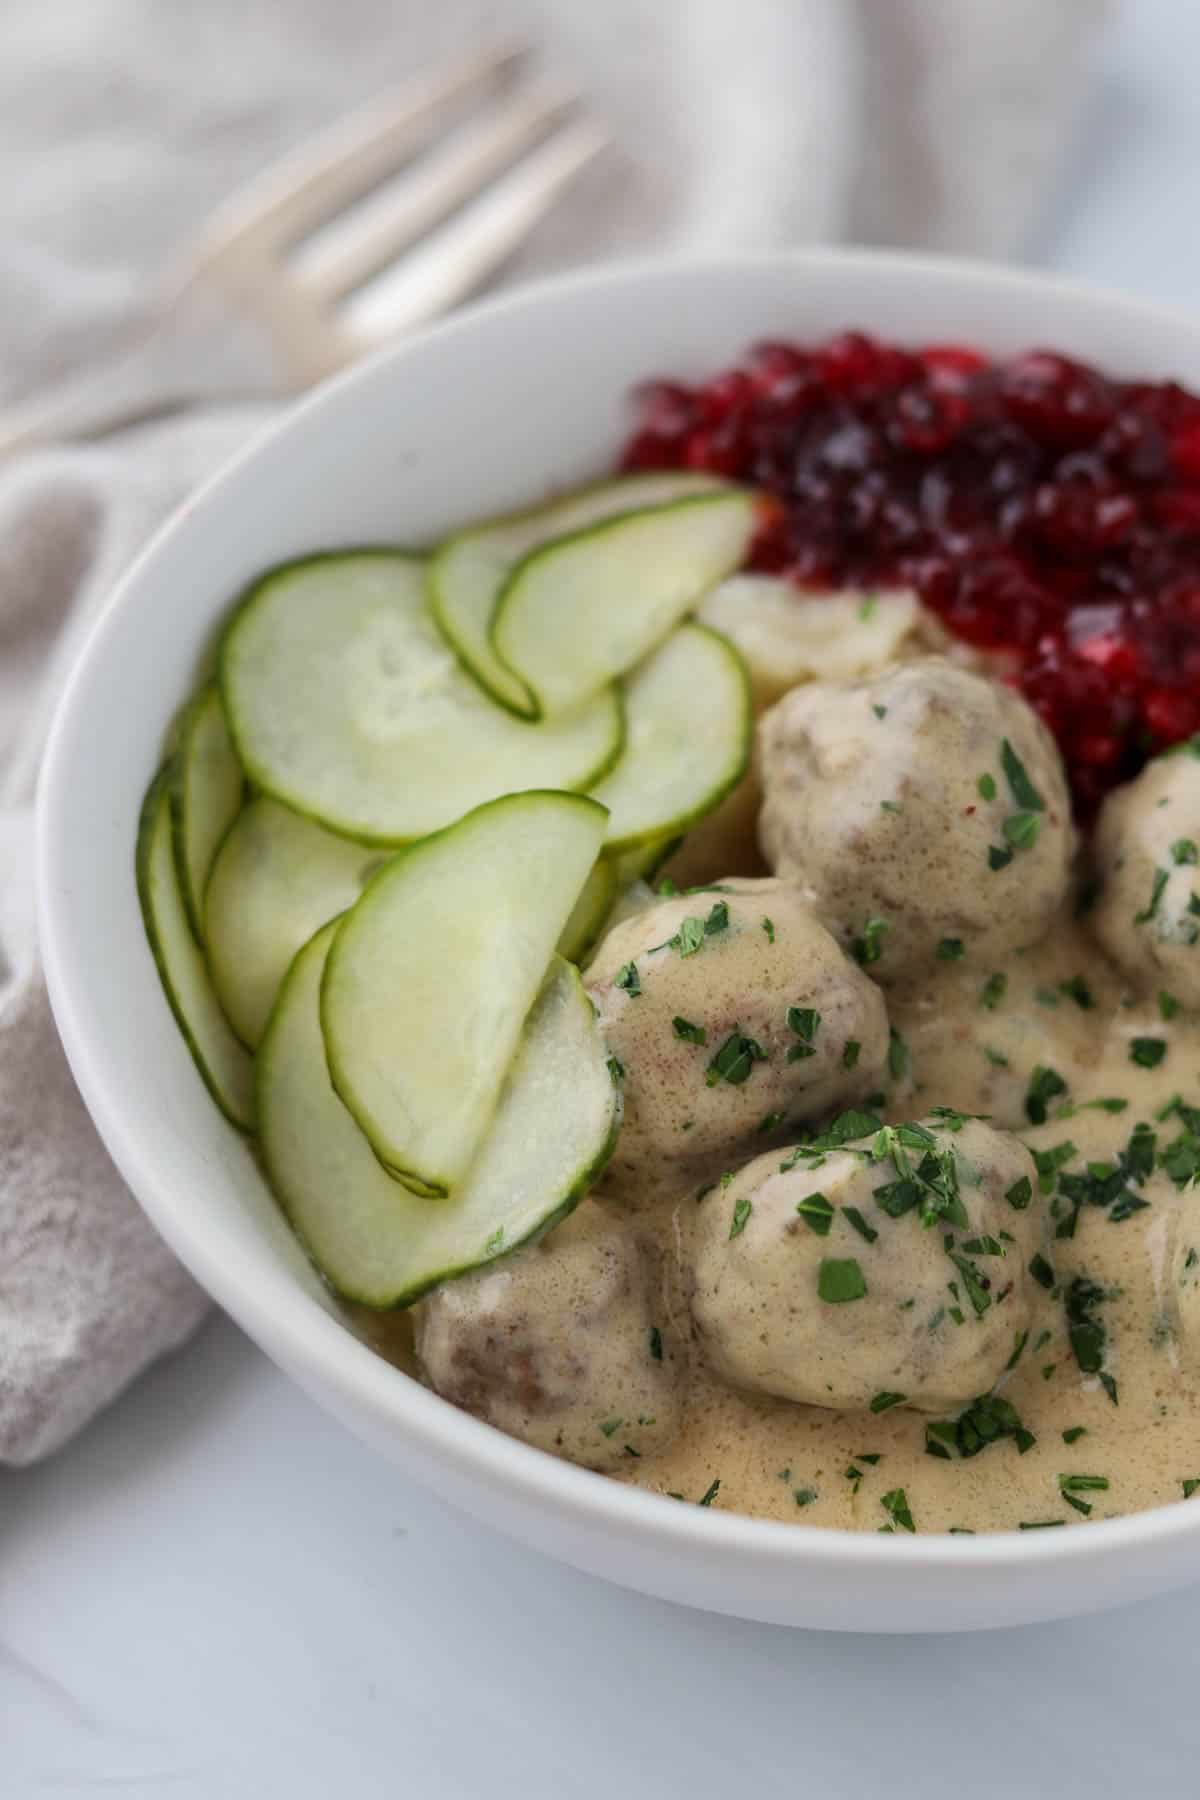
38,252 -> 1200,1631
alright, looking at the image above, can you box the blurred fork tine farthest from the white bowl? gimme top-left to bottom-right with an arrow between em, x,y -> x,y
198,47 -> 529,261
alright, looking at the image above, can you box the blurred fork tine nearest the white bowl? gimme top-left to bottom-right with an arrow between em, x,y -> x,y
345,117 -> 608,347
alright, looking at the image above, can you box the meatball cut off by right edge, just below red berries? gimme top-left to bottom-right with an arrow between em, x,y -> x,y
1090,749 -> 1200,1008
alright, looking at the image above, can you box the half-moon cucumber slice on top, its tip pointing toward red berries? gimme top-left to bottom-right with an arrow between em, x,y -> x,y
491,488 -> 757,718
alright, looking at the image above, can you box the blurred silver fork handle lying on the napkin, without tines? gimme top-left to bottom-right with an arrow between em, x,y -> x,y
0,308 -> 281,457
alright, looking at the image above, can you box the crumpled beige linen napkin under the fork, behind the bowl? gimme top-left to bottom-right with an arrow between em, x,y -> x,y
0,0 -> 1103,1463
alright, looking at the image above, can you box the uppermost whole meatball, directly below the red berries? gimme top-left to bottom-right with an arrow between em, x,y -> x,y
759,657 -> 1074,983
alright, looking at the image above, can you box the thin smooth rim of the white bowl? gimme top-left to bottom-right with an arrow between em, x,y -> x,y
34,247 -> 1200,1577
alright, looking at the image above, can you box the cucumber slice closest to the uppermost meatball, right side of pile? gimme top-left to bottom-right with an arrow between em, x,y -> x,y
592,625 -> 754,853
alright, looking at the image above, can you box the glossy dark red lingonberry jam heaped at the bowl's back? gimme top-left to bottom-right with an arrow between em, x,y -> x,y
622,331 -> 1200,814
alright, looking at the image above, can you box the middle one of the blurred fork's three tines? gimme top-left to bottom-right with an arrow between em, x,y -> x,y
291,88 -> 578,302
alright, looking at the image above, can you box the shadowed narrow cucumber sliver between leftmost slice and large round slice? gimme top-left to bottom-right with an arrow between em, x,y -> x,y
171,686 -> 245,943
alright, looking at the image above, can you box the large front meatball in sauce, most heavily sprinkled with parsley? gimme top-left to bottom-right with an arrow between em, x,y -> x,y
691,1114 -> 1040,1413
